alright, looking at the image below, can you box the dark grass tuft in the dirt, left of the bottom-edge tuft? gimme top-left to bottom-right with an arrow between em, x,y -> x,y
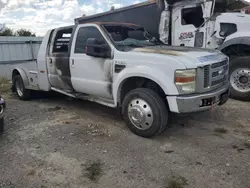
85,161 -> 103,181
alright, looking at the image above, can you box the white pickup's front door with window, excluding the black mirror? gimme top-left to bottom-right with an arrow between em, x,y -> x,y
70,26 -> 113,99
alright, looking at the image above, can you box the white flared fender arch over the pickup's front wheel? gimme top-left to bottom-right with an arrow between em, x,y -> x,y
113,66 -> 178,104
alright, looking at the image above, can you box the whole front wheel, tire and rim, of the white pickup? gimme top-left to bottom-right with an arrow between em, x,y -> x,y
122,88 -> 168,137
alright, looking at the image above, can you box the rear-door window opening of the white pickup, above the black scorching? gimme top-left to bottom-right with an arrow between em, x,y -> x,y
52,28 -> 73,53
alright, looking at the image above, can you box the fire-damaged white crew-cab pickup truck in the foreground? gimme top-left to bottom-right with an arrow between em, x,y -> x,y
12,23 -> 229,137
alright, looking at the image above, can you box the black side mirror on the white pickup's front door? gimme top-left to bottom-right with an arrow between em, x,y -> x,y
85,38 -> 111,58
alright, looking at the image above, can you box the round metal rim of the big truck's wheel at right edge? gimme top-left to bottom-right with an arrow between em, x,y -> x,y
230,68 -> 250,92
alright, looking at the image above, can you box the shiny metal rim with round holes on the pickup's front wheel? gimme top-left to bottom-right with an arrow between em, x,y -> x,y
128,99 -> 154,130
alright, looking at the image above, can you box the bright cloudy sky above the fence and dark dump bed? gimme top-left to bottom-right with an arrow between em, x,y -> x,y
0,0 -> 143,36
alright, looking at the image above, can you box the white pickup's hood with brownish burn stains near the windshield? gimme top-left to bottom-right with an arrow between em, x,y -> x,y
132,45 -> 227,68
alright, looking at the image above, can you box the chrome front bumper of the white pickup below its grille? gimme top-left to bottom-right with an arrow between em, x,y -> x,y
167,83 -> 229,113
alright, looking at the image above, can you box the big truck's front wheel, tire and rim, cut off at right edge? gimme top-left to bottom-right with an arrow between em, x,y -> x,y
230,56 -> 250,101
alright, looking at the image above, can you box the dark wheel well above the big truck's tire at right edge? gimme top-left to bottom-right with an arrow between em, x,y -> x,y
221,44 -> 250,58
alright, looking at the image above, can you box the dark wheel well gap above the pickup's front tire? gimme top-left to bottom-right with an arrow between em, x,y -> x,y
118,77 -> 166,104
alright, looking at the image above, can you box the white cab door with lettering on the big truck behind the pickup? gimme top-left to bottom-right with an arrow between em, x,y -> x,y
172,5 -> 205,47
